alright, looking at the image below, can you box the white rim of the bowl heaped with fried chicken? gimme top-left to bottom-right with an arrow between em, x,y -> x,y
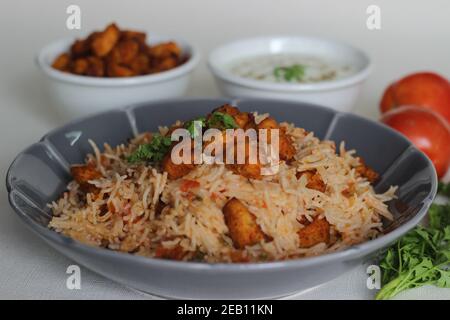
35,34 -> 201,87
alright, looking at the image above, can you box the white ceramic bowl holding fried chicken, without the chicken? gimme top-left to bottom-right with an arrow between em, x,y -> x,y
37,35 -> 200,119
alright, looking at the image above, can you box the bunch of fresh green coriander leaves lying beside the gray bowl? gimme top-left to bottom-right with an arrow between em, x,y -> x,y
375,183 -> 450,300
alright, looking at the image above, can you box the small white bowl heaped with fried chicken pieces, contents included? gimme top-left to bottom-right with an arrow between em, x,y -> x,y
36,23 -> 199,119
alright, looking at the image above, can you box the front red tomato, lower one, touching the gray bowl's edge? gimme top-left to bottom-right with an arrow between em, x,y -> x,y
381,106 -> 450,177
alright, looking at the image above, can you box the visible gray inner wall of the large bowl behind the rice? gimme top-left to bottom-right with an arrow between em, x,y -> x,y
7,99 -> 437,255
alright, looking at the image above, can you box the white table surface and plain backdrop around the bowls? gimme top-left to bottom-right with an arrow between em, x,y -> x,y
0,0 -> 450,299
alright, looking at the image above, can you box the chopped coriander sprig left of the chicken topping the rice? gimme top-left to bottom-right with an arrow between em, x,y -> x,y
127,134 -> 172,163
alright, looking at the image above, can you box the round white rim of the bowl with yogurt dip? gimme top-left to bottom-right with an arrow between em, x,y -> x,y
207,34 -> 373,92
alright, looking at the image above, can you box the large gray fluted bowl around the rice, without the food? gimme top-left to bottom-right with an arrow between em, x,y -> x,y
6,99 -> 437,299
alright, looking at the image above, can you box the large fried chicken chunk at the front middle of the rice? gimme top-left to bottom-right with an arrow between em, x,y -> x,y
222,198 -> 268,249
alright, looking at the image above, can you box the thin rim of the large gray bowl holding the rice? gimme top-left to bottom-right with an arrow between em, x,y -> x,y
6,97 -> 437,273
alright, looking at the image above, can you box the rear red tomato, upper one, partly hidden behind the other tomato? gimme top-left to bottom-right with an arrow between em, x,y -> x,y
380,72 -> 450,123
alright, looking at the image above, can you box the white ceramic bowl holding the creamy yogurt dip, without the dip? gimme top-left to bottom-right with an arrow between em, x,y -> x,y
208,36 -> 372,111
